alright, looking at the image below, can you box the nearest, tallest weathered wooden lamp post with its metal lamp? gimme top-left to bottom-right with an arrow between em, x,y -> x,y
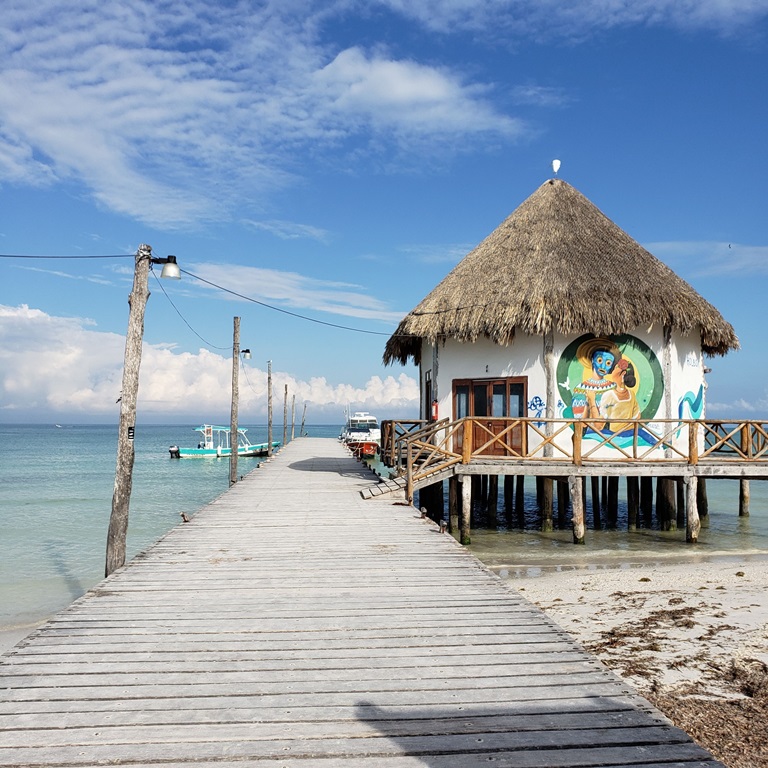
104,244 -> 181,576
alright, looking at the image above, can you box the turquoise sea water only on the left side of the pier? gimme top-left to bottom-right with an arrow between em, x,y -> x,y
0,423 -> 341,628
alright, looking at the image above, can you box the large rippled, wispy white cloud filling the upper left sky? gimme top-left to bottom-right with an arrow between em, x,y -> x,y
0,0 -> 516,227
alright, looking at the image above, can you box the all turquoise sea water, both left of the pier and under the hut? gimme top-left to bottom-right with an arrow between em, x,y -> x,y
0,424 -> 768,629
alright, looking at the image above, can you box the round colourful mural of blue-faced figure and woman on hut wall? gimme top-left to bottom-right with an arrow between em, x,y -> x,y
557,334 -> 664,446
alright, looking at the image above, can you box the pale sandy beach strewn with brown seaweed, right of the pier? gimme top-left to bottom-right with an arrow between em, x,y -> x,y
508,556 -> 768,768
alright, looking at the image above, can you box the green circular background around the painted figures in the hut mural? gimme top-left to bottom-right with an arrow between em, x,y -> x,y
557,333 -> 664,419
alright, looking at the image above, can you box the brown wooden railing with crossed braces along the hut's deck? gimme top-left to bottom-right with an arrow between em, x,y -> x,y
382,417 -> 768,500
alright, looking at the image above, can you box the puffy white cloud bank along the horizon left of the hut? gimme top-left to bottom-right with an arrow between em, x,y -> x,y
0,305 -> 419,423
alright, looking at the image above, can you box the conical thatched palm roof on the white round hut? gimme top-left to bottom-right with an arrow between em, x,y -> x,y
384,179 -> 739,364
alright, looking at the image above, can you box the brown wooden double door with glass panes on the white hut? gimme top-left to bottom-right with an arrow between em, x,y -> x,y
453,376 -> 528,456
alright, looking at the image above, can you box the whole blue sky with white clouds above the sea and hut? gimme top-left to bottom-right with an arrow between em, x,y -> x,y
0,0 -> 768,425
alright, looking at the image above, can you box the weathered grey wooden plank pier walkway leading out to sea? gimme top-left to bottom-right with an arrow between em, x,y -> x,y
0,438 -> 720,768
